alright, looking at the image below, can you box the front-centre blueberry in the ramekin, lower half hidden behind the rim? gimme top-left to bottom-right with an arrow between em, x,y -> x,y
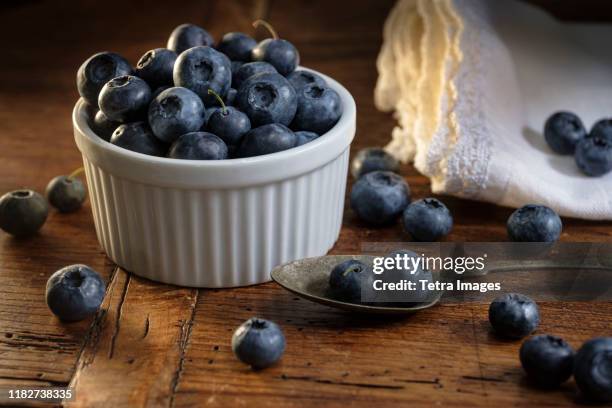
168,132 -> 227,160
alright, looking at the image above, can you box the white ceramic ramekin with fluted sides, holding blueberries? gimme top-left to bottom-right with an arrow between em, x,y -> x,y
73,68 -> 356,288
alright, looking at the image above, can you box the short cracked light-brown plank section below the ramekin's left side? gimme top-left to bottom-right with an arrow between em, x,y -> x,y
66,269 -> 198,407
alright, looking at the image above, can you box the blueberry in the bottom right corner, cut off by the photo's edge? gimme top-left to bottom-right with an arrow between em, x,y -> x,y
574,337 -> 612,402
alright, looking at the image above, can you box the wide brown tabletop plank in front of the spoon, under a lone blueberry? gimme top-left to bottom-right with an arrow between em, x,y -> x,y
169,284 -> 612,407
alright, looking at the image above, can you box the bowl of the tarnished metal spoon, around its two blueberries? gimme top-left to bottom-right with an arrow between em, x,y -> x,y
270,255 -> 443,314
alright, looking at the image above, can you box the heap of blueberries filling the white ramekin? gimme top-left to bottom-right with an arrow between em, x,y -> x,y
77,20 -> 342,160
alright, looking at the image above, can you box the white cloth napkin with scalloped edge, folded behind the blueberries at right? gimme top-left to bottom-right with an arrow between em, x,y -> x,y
375,0 -> 612,219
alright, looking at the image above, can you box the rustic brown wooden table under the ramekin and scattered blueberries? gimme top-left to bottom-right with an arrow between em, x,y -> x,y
0,0 -> 612,407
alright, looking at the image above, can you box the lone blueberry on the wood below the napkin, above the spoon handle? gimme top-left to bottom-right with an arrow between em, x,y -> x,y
507,204 -> 563,242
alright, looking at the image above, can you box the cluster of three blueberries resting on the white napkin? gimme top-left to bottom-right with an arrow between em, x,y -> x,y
544,112 -> 612,177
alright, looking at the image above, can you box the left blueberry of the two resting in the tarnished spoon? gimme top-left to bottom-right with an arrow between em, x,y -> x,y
329,259 -> 368,303
